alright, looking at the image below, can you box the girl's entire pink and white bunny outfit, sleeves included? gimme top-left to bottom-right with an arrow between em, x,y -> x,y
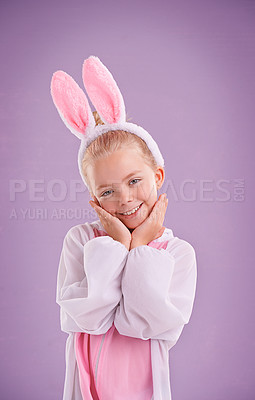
56,220 -> 197,400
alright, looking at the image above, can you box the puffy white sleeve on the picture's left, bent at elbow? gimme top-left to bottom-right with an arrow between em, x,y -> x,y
56,225 -> 128,334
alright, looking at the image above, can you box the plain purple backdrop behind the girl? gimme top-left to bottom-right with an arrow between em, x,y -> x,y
0,0 -> 255,400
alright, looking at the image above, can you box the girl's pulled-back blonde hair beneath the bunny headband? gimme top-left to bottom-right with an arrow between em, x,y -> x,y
82,111 -> 157,191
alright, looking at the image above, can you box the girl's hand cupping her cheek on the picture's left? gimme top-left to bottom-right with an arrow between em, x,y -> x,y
89,196 -> 131,250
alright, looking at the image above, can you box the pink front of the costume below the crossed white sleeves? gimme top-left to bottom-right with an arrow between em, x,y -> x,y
75,324 -> 153,400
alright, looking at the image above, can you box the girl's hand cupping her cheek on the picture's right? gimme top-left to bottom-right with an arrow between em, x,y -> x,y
130,193 -> 168,250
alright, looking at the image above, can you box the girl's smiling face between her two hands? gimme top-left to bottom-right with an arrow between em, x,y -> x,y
87,148 -> 164,229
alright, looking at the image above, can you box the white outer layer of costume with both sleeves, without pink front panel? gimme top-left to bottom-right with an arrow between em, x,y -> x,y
56,220 -> 197,400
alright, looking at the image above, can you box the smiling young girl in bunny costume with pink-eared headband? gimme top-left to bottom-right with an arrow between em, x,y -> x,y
51,56 -> 197,400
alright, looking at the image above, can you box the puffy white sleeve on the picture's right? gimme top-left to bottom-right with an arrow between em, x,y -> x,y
114,238 -> 197,343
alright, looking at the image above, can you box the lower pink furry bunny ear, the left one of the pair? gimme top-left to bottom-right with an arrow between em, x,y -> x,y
51,71 -> 95,139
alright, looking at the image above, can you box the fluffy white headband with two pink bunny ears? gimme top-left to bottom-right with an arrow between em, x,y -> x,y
51,56 -> 164,191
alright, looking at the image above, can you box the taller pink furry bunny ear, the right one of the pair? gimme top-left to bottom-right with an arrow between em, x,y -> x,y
82,56 -> 126,124
